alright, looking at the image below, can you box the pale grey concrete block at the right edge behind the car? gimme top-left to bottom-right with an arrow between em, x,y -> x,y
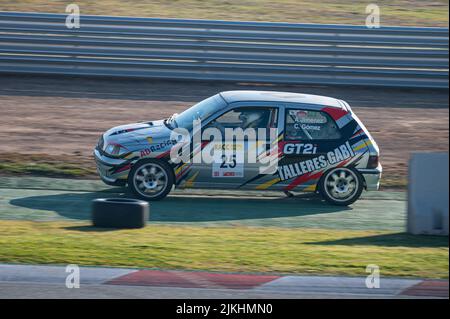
407,153 -> 449,235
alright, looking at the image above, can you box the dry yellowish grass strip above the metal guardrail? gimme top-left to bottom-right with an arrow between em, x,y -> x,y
0,0 -> 448,26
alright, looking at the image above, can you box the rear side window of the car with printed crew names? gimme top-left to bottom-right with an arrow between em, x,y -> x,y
284,109 -> 341,141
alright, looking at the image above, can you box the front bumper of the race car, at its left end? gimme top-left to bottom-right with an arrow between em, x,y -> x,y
94,149 -> 131,183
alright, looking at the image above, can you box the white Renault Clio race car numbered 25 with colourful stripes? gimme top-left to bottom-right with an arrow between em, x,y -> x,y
94,91 -> 382,205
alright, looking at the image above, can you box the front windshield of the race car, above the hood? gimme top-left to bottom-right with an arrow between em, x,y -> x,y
167,94 -> 226,131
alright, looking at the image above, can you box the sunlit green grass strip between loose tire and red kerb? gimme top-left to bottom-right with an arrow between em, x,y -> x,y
0,221 -> 449,278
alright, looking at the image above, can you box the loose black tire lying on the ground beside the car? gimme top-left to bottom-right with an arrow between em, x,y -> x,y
92,198 -> 149,228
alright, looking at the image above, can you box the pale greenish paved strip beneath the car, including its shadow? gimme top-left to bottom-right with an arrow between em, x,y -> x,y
0,177 -> 406,231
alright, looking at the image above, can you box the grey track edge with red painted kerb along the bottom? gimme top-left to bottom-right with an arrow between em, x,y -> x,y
0,264 -> 448,299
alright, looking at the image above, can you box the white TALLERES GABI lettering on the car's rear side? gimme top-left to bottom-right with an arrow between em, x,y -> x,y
278,142 -> 355,181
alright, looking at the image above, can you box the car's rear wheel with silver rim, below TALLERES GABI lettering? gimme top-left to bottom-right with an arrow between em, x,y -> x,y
319,167 -> 364,206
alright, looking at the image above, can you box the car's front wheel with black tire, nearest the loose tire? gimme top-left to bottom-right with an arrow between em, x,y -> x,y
128,159 -> 175,201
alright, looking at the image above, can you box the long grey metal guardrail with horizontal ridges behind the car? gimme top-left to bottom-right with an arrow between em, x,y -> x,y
0,12 -> 449,89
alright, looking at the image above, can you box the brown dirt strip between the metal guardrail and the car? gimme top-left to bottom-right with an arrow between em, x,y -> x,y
0,78 -> 449,186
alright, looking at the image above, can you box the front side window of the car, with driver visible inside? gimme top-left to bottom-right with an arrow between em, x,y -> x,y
208,107 -> 277,130
